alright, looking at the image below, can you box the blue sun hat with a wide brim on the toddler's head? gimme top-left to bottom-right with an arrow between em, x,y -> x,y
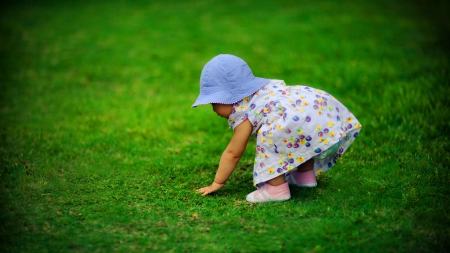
192,54 -> 270,107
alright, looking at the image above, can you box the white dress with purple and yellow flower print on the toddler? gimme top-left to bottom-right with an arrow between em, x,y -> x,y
228,80 -> 361,186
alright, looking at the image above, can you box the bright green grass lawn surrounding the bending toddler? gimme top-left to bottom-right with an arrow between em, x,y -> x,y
0,0 -> 450,252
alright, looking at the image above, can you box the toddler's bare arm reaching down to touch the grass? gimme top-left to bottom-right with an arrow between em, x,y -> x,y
198,120 -> 253,195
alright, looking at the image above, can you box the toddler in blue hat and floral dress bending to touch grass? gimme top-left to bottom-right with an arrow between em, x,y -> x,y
192,54 -> 361,203
